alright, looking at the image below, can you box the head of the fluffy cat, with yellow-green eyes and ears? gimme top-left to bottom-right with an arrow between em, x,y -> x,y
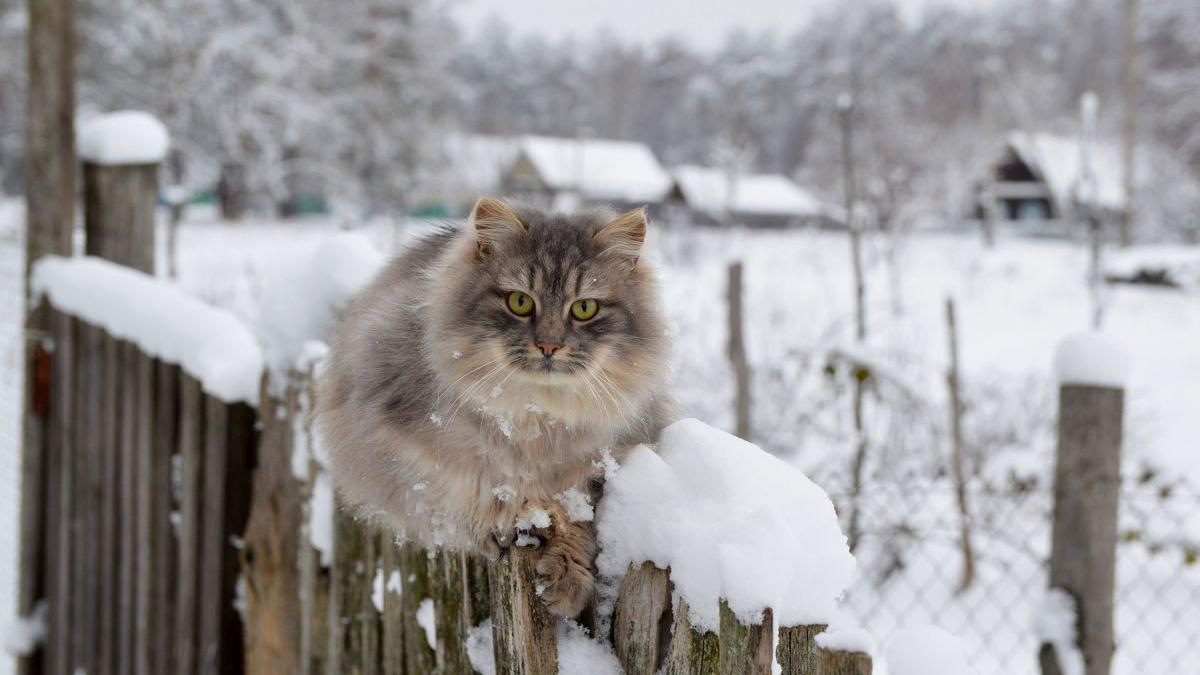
436,199 -> 666,413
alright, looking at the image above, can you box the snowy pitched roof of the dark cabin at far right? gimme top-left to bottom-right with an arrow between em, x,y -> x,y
1004,131 -> 1124,210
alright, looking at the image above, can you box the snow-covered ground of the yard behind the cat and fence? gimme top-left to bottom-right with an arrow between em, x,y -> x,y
0,200 -> 1200,675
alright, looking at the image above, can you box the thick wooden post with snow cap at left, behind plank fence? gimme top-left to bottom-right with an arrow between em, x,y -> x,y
79,110 -> 169,274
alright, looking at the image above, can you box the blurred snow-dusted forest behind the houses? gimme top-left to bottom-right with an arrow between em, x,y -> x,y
0,0 -> 1200,239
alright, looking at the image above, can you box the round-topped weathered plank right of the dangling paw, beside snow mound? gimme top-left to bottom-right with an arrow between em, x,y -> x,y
612,562 -> 671,675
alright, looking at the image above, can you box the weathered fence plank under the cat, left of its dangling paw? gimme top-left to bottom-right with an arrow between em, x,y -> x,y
489,546 -> 558,675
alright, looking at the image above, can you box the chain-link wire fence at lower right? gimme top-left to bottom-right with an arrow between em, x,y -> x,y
835,476 -> 1200,675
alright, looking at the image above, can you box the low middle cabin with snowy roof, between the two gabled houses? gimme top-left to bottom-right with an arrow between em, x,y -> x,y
670,166 -> 845,227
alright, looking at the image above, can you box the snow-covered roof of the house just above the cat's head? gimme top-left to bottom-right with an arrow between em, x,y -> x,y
520,136 -> 671,202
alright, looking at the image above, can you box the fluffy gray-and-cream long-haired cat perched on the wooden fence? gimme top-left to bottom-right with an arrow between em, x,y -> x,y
317,198 -> 670,616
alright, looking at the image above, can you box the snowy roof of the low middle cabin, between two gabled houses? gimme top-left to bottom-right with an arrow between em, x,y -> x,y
671,166 -> 827,217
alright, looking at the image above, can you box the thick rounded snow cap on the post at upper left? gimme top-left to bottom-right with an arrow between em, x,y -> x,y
78,110 -> 170,166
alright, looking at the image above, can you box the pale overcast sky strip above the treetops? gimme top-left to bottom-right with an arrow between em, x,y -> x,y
452,0 -> 1003,47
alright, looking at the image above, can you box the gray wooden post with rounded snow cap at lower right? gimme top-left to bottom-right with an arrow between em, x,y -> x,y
1038,333 -> 1128,675
